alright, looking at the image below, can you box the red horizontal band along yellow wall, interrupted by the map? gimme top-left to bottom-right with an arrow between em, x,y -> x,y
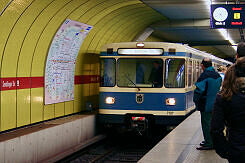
0,75 -> 100,91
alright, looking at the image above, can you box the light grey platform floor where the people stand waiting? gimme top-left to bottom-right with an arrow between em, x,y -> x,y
138,112 -> 228,163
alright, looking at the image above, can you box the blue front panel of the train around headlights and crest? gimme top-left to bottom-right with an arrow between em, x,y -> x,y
100,92 -> 186,111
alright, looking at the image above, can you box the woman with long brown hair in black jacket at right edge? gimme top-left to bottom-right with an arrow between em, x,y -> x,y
211,57 -> 245,163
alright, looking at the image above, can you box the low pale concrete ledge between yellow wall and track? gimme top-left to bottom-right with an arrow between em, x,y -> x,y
0,112 -> 103,163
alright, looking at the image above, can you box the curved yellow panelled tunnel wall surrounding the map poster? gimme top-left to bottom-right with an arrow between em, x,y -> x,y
0,0 -> 164,131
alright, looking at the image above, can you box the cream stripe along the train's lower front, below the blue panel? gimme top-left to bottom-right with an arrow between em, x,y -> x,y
99,106 -> 195,116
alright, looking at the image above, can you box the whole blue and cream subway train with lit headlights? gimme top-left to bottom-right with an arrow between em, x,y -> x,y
99,42 -> 232,131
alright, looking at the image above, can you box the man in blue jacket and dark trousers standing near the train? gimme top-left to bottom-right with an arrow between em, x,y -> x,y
193,58 -> 222,150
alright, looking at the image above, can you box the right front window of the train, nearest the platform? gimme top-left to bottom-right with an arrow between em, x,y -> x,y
164,58 -> 185,88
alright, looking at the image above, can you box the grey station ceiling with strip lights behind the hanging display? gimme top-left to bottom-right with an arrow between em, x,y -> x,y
142,0 -> 244,57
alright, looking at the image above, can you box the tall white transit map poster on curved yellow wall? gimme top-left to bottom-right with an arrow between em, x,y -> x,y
45,19 -> 92,104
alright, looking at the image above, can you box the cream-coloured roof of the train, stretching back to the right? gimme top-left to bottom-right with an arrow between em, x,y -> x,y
101,42 -> 233,64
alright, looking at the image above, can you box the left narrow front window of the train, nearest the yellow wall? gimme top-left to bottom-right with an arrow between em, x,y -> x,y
100,58 -> 116,87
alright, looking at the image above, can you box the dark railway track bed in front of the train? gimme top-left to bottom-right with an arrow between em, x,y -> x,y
58,129 -> 168,163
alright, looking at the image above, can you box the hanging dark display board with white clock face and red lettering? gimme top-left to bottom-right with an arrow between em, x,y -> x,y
210,4 -> 245,28
